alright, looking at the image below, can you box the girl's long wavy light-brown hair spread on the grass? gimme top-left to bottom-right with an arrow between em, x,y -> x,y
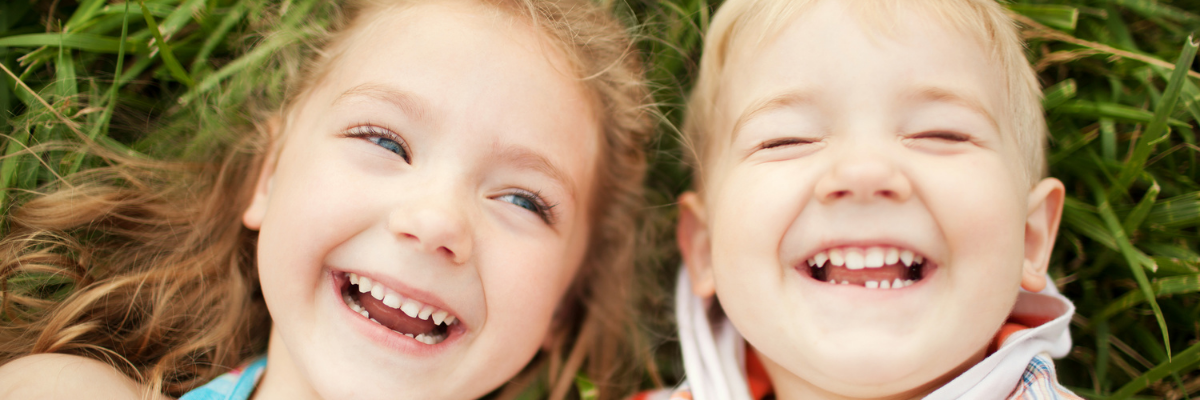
0,0 -> 653,399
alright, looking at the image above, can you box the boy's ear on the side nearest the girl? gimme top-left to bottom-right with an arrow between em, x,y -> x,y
676,192 -> 716,298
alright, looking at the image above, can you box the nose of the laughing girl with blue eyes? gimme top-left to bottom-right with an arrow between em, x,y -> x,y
388,196 -> 473,264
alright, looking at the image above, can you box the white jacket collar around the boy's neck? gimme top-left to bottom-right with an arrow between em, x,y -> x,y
676,268 -> 1075,400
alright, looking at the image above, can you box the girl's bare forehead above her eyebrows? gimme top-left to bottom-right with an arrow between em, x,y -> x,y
278,4 -> 601,196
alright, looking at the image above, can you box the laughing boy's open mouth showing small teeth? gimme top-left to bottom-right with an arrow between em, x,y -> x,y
805,246 -> 932,289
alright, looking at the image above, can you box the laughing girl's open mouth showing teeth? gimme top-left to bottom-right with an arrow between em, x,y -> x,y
342,273 -> 458,345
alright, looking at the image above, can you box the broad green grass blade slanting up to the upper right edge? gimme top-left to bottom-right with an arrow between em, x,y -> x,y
1108,36 -> 1200,198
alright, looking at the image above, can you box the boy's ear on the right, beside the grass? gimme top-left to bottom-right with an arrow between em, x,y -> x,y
1021,178 -> 1067,292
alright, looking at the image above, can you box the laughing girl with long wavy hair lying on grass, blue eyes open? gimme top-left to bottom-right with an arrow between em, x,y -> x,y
0,0 -> 650,399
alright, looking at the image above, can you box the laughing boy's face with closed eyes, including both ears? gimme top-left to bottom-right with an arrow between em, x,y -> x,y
679,1 -> 1062,399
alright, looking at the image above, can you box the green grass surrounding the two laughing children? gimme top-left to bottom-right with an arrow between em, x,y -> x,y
0,0 -> 1200,399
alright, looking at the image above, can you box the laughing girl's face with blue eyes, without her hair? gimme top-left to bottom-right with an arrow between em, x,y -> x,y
245,1 -> 600,399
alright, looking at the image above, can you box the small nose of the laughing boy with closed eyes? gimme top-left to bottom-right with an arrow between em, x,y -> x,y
816,154 -> 912,203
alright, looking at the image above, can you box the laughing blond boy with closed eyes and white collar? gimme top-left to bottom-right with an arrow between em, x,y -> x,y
657,0 -> 1076,399
